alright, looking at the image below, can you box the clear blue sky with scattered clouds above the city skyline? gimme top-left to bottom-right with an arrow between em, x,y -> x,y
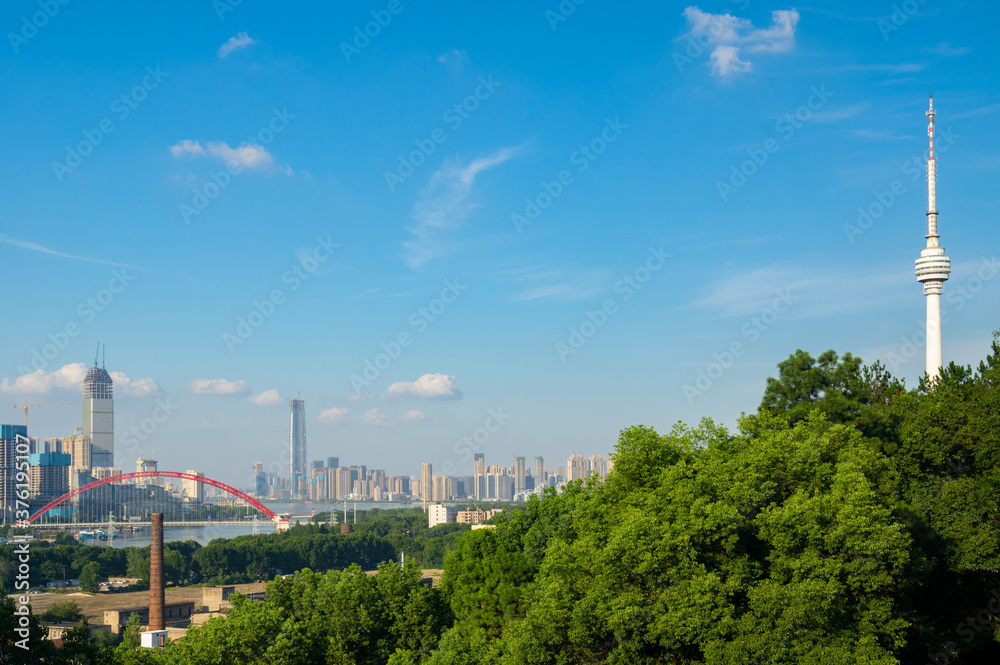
0,0 -> 1000,485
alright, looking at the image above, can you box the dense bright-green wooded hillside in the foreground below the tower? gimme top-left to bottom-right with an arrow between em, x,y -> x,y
5,334 -> 1000,665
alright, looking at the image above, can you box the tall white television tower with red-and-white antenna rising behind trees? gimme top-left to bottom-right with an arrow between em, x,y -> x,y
916,97 -> 951,380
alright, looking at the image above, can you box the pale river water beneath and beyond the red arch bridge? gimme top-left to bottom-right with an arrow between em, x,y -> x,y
104,502 -> 420,548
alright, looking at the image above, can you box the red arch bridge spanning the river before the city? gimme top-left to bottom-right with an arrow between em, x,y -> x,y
27,471 -> 288,528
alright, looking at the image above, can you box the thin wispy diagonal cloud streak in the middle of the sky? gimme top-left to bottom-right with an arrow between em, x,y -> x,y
403,146 -> 522,268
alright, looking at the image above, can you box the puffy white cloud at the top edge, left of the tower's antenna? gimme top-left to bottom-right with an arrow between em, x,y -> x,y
684,7 -> 799,79
